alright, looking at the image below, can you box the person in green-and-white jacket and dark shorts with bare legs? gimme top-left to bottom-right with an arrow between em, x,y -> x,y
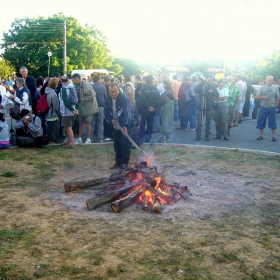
59,76 -> 79,149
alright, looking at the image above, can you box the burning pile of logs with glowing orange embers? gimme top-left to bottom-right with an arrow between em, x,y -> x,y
64,150 -> 187,213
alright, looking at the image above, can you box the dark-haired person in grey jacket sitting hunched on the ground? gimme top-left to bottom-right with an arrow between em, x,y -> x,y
15,109 -> 43,147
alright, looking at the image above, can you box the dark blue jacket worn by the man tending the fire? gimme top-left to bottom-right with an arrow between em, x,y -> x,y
104,92 -> 133,127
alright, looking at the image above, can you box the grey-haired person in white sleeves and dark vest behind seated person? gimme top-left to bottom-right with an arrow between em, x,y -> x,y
9,78 -> 32,120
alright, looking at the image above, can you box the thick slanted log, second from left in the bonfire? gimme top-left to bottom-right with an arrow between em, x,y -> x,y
86,185 -> 134,210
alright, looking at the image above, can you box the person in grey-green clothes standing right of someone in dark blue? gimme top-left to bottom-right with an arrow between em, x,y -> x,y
159,92 -> 174,143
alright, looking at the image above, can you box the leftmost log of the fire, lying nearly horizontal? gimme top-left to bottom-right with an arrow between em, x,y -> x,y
64,177 -> 108,192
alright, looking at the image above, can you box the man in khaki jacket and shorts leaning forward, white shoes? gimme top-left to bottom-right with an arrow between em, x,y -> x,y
72,73 -> 98,144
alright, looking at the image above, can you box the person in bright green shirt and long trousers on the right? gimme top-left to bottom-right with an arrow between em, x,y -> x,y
225,76 -> 240,136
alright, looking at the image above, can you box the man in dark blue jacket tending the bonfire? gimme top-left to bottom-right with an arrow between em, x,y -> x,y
104,83 -> 133,169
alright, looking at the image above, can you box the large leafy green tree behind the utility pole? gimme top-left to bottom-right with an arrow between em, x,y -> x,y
1,13 -> 113,76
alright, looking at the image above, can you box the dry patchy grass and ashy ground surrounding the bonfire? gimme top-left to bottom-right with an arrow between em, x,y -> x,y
0,145 -> 280,280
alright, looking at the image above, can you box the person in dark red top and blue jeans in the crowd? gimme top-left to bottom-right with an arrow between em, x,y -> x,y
177,75 -> 191,130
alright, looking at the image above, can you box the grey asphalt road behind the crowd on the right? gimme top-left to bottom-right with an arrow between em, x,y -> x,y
152,114 -> 280,153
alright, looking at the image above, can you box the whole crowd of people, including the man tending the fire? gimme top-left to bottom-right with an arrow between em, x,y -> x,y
0,67 -> 279,164
